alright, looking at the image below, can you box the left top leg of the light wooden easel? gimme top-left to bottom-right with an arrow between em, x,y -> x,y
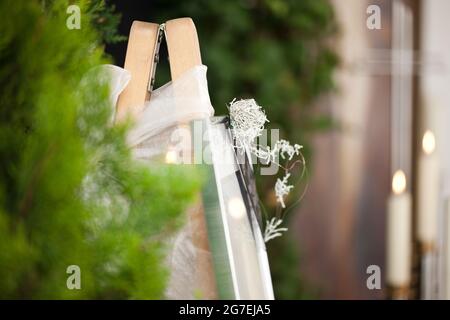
116,21 -> 158,122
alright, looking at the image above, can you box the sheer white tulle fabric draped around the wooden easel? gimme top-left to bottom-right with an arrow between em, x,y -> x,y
102,65 -> 214,299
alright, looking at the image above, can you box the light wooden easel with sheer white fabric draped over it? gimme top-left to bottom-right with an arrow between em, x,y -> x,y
116,18 -> 217,299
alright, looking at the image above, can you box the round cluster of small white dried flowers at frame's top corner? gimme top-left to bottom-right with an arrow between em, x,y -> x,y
229,99 -> 269,151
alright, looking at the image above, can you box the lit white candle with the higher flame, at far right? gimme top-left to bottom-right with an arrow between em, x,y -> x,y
417,130 -> 439,250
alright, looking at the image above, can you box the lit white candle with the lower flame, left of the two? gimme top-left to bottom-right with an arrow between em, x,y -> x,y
386,170 -> 411,288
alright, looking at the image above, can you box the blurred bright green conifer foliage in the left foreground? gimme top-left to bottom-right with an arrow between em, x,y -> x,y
0,0 -> 200,299
